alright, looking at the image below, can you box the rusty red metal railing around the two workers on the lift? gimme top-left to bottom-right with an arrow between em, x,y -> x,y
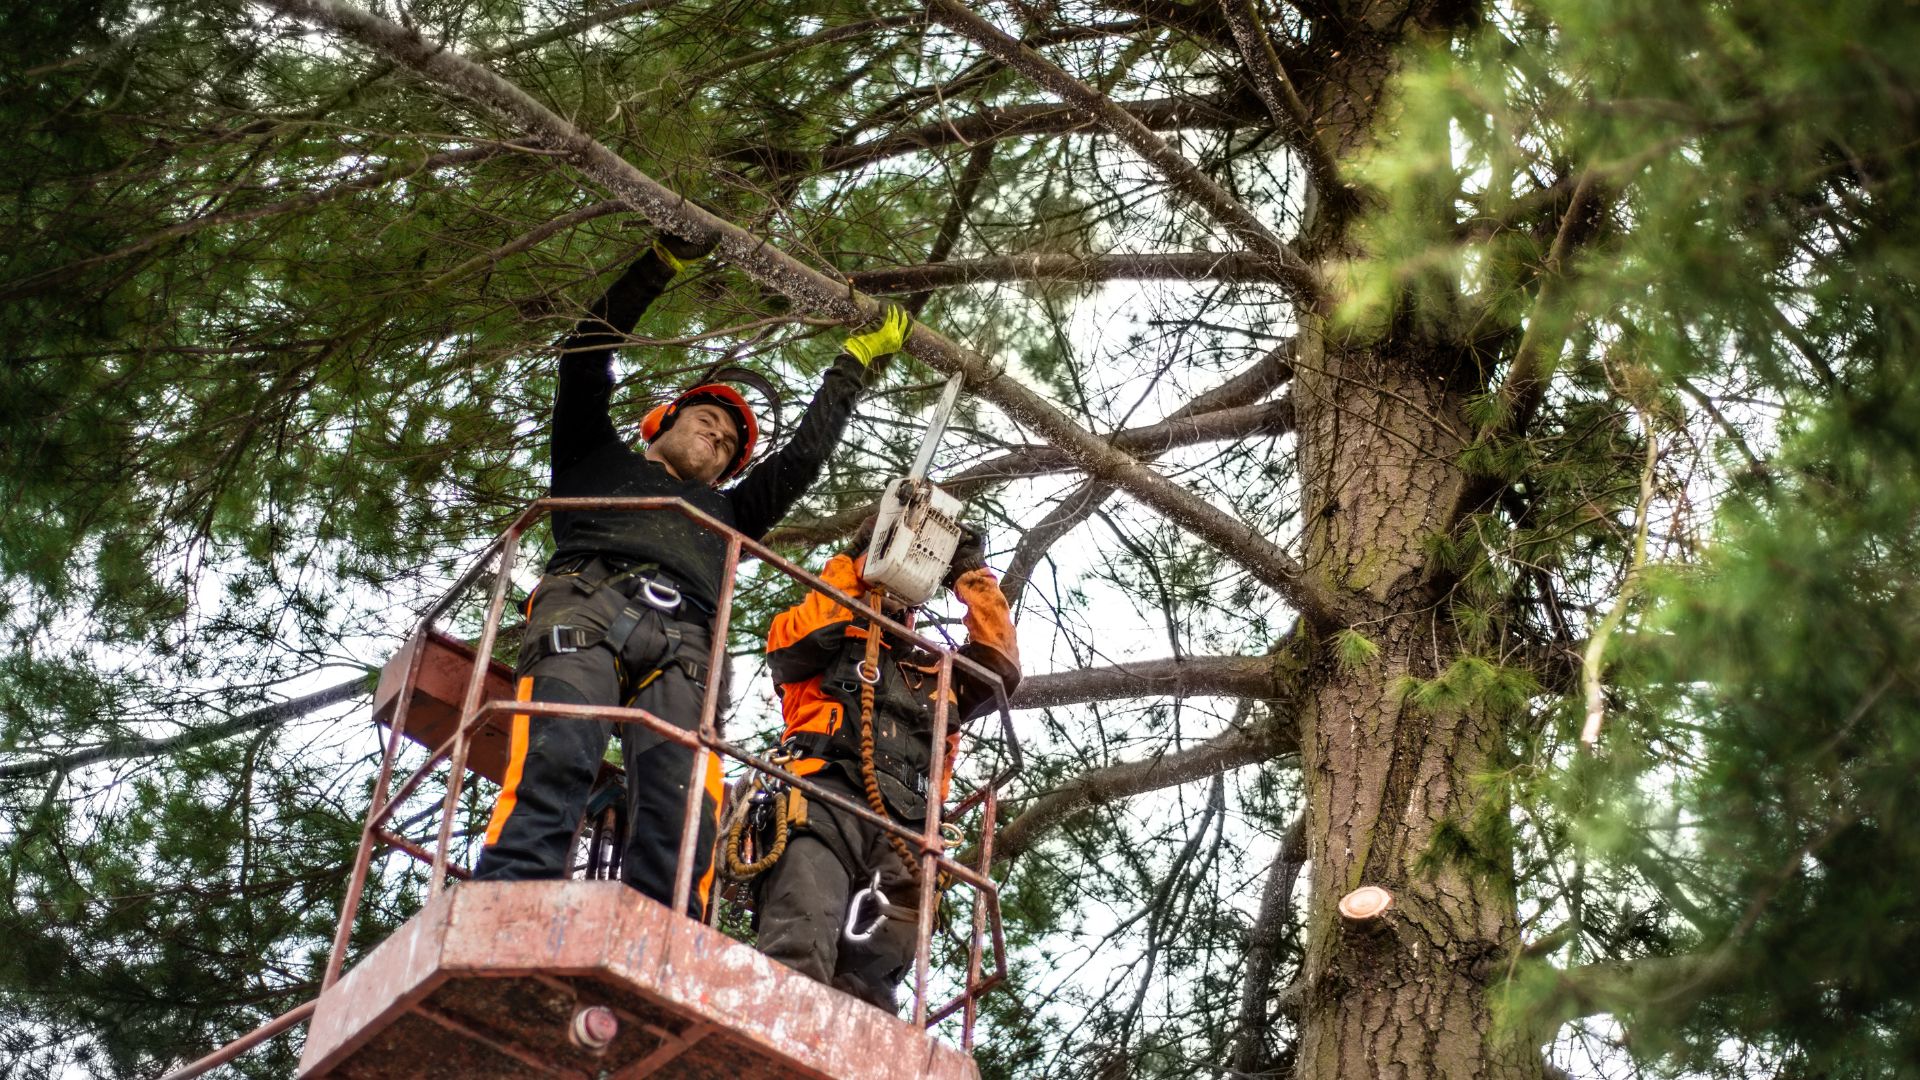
321,498 -> 1021,1030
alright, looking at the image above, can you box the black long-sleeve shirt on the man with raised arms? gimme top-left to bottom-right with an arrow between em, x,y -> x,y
553,252 -> 862,607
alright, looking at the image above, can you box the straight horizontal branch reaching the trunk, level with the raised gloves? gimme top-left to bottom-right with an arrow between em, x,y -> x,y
847,252 -> 1283,294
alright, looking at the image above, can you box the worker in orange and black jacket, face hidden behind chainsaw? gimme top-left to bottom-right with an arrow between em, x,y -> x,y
755,532 -> 1020,1011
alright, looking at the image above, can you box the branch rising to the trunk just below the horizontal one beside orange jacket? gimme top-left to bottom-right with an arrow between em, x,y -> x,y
993,707 -> 1300,863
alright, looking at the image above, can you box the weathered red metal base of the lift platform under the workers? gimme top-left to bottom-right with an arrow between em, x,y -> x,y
300,880 -> 979,1080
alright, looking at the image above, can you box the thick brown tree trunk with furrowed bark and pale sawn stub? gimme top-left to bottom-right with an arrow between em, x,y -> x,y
1294,338 -> 1540,1080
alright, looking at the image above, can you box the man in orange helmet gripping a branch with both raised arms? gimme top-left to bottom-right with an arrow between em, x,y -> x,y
474,236 -> 912,917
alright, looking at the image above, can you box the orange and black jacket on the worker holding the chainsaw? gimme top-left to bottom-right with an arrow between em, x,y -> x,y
766,555 -> 1020,809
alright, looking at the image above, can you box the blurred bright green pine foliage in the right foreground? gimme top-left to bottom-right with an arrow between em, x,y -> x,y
1350,0 -> 1920,1076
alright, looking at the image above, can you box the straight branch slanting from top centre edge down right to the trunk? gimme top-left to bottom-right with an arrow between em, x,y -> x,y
927,0 -> 1321,307
